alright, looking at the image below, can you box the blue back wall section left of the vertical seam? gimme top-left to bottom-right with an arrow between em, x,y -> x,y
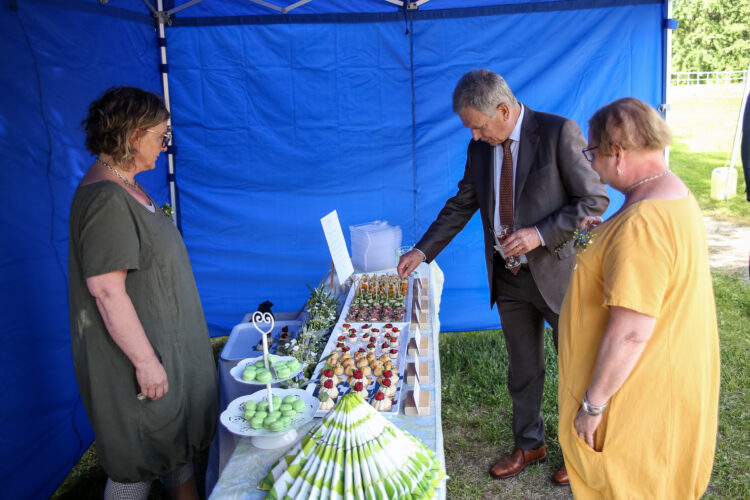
168,23 -> 414,335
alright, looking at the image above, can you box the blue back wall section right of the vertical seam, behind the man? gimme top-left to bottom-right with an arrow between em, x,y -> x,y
413,5 -> 663,331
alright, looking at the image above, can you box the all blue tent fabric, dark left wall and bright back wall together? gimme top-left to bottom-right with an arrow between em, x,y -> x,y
0,0 -> 666,498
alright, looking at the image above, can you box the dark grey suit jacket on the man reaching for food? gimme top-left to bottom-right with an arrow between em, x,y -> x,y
416,106 -> 609,313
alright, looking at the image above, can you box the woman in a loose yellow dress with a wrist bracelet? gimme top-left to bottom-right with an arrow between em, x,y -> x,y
558,98 -> 719,499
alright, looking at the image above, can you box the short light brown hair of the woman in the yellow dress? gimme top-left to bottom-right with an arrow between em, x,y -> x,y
589,97 -> 672,156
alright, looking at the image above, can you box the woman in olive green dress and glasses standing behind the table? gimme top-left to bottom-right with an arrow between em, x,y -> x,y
69,87 -> 218,498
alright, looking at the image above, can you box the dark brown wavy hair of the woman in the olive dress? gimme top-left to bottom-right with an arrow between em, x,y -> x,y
81,87 -> 169,164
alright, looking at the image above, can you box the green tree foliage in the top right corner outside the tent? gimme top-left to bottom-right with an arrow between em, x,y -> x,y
672,0 -> 750,71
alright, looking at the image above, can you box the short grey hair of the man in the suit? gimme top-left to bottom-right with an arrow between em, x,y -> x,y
453,69 -> 518,118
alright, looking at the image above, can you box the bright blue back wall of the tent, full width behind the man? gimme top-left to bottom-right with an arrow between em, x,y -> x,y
168,4 -> 662,335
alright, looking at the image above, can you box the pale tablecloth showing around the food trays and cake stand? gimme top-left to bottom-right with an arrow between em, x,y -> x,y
206,262 -> 445,500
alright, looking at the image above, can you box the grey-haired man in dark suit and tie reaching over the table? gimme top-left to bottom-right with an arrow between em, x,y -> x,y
398,70 -> 609,484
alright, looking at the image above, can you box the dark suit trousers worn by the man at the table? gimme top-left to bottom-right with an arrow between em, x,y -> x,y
493,254 -> 559,450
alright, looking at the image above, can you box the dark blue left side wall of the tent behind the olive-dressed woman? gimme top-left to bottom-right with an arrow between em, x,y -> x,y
0,2 -> 168,499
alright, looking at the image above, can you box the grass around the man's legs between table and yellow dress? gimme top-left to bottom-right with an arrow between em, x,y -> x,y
440,330 -> 572,500
